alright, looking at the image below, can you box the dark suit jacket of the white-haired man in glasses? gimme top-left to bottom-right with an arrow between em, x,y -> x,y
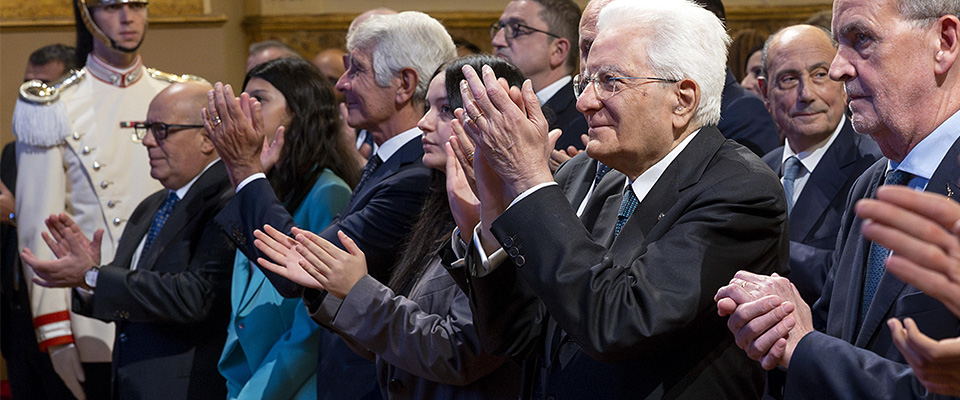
468,127 -> 787,399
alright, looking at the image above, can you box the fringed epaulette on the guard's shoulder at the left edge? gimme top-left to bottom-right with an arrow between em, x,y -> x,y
13,69 -> 86,147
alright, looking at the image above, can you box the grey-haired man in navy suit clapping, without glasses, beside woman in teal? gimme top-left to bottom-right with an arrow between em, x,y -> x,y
208,12 -> 456,399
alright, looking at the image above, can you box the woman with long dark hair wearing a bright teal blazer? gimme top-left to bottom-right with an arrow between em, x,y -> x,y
218,59 -> 358,399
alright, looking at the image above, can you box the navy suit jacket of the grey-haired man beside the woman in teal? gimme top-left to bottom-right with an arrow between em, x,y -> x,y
217,135 -> 431,399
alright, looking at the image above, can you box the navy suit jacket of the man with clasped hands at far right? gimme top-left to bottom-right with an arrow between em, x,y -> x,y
784,133 -> 960,399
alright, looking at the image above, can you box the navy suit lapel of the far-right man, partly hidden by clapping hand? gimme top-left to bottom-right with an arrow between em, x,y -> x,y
857,135 -> 960,345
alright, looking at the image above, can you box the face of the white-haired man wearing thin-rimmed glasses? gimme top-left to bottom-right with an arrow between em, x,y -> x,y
577,28 -> 676,173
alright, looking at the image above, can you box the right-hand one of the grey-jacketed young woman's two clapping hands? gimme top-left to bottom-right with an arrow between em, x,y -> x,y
293,228 -> 367,299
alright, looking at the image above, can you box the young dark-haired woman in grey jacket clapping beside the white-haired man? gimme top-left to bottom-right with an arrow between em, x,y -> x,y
255,55 -> 523,399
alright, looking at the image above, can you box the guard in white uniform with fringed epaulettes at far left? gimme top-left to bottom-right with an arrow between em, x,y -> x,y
13,0 -> 206,398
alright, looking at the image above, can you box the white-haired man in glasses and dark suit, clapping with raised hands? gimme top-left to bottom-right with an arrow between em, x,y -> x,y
457,0 -> 787,399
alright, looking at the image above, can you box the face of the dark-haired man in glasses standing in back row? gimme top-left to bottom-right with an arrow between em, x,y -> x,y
490,0 -> 555,83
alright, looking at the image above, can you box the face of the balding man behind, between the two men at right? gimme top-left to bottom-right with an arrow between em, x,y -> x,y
764,26 -> 844,152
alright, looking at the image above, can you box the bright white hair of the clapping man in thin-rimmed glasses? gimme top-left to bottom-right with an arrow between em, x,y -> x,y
597,0 -> 730,126
